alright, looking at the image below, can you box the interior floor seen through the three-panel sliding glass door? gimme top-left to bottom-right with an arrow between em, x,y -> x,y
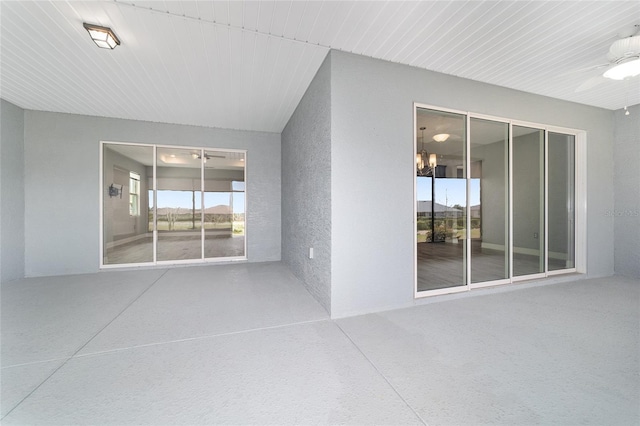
104,233 -> 244,265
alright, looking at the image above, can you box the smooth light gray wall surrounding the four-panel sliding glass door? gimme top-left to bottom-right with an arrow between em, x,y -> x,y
330,51 -> 614,317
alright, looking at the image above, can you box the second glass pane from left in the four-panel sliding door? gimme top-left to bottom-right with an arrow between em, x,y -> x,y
469,118 -> 510,283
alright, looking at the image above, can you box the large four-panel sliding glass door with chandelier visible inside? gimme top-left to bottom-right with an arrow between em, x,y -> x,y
415,105 -> 584,296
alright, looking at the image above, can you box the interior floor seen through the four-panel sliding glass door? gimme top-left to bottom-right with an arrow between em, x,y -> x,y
417,240 -> 564,291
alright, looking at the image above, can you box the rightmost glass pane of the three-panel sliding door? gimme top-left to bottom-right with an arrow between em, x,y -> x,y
204,151 -> 245,258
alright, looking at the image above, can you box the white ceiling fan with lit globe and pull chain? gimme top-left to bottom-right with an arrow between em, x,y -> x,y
576,25 -> 640,92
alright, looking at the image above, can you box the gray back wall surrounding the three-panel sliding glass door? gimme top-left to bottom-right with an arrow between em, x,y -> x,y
24,111 -> 281,276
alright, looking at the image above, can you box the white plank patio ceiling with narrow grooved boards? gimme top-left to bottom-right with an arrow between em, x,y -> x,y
0,0 -> 640,132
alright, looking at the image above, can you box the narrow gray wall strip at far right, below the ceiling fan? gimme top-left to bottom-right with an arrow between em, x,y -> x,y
608,105 -> 640,278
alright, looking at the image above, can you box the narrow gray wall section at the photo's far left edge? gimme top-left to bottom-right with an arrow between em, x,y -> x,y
0,99 -> 24,282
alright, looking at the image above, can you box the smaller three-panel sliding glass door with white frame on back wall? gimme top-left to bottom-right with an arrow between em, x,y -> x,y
101,142 -> 246,266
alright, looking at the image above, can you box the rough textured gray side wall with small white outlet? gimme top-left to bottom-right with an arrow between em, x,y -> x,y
282,56 -> 331,311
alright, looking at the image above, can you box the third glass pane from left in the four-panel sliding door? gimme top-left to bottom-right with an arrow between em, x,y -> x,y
512,126 -> 545,277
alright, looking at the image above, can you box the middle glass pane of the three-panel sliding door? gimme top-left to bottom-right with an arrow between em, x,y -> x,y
156,148 -> 202,261
